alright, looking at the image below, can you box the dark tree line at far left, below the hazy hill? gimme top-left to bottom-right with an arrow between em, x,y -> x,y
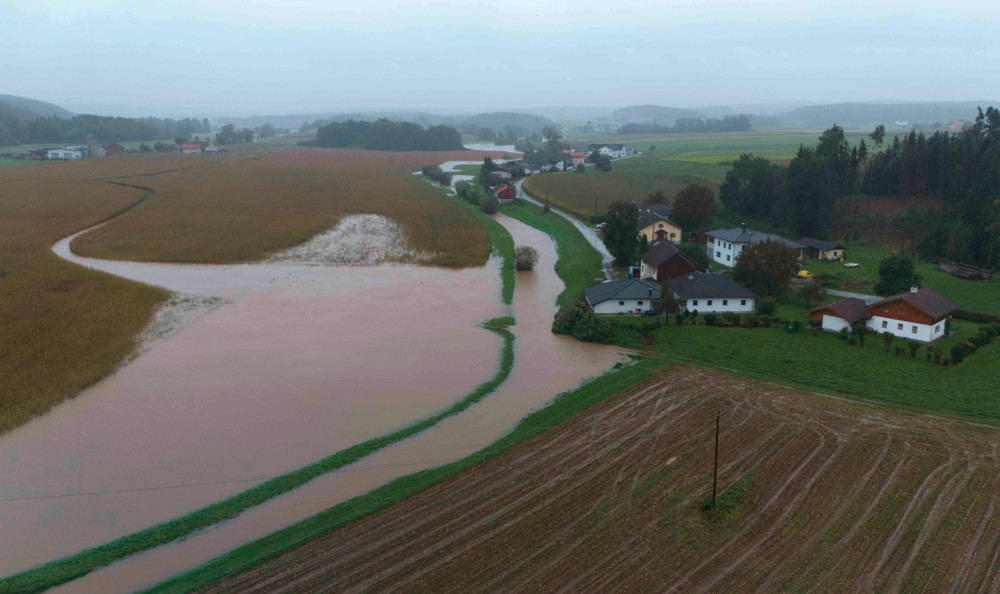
0,115 -> 211,146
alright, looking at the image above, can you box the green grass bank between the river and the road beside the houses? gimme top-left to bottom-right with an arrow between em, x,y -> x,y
500,200 -> 604,307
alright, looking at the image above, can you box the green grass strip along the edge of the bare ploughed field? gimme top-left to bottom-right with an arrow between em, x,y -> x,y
150,359 -> 659,592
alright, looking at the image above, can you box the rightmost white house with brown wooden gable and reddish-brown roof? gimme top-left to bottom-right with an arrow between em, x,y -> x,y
868,287 -> 958,342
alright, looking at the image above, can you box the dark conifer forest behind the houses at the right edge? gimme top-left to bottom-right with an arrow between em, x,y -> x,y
719,107 -> 1000,267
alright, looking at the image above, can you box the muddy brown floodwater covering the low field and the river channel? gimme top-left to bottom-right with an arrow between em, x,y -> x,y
0,209 -> 622,592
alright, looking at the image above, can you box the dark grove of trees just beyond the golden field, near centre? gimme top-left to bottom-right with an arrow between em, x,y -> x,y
316,118 -> 463,151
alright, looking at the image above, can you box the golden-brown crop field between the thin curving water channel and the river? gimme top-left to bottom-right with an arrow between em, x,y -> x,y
73,150 -> 504,266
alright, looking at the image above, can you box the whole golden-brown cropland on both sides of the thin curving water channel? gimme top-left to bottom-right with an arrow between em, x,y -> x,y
0,146 -> 508,433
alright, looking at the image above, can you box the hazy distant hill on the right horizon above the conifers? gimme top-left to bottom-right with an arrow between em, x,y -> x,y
775,101 -> 1000,128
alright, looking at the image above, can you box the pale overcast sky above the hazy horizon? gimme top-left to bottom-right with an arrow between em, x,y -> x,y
0,0 -> 1000,117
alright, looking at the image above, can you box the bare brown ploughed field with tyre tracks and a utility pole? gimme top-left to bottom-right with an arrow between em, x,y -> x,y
203,368 -> 1000,592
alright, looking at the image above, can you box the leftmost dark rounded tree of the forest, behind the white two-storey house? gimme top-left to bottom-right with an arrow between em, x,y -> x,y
719,153 -> 783,218
